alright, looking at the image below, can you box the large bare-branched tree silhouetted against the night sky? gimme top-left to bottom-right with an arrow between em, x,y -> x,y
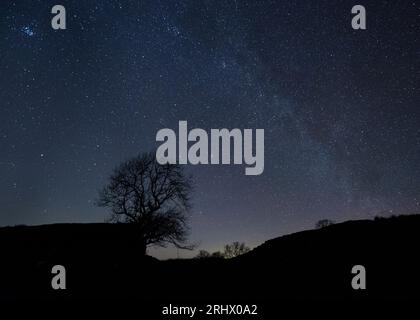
97,153 -> 192,254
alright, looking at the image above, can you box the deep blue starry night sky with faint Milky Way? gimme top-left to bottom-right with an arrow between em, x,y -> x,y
0,0 -> 420,257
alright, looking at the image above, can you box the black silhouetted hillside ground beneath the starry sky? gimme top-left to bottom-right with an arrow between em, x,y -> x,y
0,215 -> 420,301
